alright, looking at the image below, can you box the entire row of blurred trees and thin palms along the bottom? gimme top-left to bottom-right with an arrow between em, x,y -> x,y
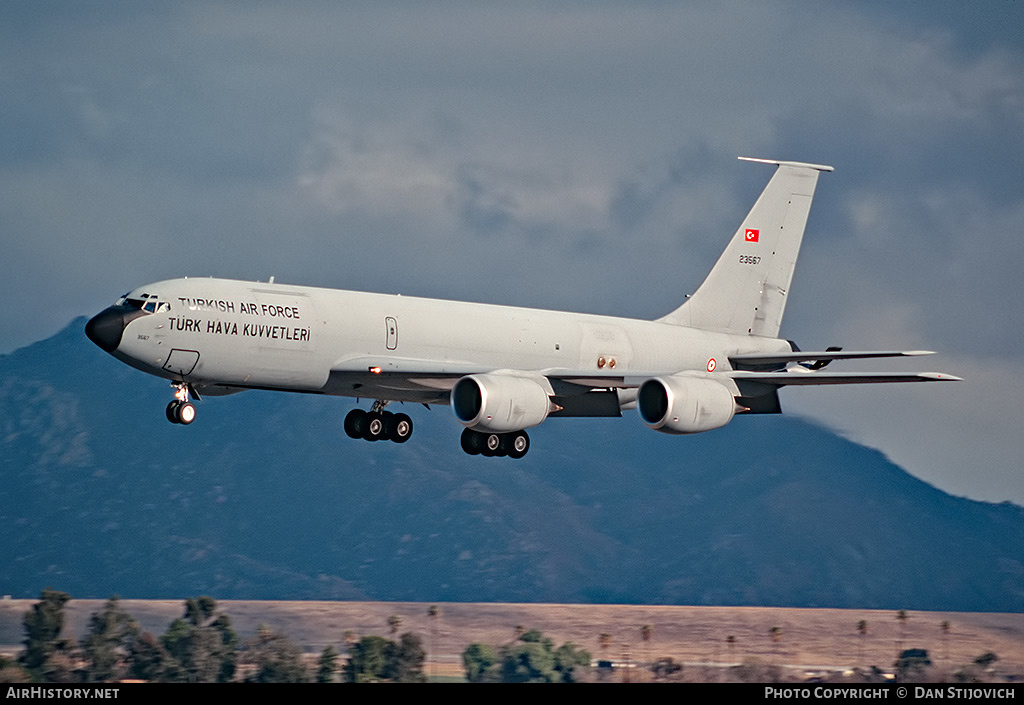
0,588 -> 998,683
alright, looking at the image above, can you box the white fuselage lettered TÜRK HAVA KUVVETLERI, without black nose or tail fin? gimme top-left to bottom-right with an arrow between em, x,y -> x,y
108,279 -> 791,401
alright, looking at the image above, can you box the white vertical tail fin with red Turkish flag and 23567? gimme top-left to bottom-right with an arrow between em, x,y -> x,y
658,157 -> 833,338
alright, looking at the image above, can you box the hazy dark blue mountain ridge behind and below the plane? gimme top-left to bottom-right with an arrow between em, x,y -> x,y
0,319 -> 1024,612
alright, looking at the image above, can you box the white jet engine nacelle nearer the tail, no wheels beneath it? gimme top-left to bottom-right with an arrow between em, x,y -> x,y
637,376 -> 736,433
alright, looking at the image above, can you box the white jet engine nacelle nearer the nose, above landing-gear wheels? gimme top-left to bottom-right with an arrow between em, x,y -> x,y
452,374 -> 551,433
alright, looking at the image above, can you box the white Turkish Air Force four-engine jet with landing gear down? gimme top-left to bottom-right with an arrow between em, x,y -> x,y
85,157 -> 959,458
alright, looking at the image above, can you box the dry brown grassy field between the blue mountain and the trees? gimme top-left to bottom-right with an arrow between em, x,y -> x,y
0,599 -> 1024,678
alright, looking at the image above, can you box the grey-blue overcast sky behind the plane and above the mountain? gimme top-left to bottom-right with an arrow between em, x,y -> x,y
0,0 -> 1024,504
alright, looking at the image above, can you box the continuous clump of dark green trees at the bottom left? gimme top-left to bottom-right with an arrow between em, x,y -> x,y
0,589 -> 426,683
